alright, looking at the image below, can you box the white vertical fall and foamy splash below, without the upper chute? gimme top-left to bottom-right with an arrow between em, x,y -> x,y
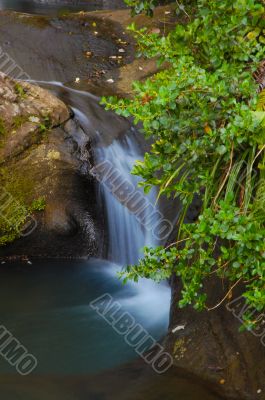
96,130 -> 170,328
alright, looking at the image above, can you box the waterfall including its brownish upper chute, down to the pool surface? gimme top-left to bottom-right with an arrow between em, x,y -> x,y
29,81 -> 167,266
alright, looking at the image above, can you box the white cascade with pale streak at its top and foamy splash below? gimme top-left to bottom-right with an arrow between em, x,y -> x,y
66,97 -> 170,331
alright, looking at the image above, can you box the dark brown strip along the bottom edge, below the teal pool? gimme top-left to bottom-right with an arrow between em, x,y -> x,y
0,360 -> 221,400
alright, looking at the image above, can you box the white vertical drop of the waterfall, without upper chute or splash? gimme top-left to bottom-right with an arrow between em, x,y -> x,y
96,129 -> 158,265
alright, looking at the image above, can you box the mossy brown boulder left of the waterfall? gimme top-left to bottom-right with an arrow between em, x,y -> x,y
0,75 -> 103,257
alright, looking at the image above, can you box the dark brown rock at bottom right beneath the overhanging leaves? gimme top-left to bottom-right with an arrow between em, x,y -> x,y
166,279 -> 265,400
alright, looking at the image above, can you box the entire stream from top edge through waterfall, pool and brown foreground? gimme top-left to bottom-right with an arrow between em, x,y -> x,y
0,1 -> 221,400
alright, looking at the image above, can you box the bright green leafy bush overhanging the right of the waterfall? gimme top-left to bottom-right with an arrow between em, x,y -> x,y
103,0 -> 265,324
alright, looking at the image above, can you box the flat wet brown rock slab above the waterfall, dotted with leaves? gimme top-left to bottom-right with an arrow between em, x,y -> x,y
0,11 -> 131,83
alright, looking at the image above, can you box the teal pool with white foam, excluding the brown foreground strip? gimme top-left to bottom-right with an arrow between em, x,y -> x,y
0,260 -> 170,375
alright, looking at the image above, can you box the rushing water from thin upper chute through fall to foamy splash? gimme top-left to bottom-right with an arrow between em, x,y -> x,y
28,81 -> 170,330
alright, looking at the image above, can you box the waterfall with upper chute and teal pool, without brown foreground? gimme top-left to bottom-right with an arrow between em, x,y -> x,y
0,82 -> 170,374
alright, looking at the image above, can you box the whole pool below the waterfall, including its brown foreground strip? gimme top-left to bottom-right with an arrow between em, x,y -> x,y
0,260 -> 221,400
